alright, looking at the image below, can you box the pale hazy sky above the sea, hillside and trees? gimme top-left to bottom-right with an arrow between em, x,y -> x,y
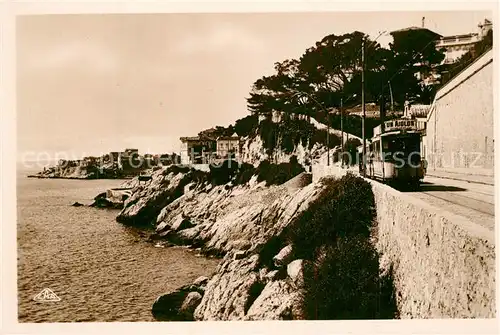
16,11 -> 492,159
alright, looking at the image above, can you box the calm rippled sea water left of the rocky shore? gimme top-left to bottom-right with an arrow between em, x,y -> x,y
17,168 -> 217,322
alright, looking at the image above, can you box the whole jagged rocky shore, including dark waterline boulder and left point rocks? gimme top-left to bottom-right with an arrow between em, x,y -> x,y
103,158 -> 332,320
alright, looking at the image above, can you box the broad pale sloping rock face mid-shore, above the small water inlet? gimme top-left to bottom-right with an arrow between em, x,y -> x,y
157,173 -> 322,255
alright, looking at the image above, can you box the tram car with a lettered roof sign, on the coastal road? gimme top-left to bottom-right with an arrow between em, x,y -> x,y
358,119 -> 425,188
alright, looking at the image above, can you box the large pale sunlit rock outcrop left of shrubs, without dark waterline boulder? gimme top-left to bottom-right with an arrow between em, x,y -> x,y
144,172 -> 324,320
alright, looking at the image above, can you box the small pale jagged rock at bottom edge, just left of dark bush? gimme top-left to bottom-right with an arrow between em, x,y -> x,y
244,280 -> 301,320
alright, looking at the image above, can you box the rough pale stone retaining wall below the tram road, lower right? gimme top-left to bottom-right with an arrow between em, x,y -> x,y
370,181 -> 496,318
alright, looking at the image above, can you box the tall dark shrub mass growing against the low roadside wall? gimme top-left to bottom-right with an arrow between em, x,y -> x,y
287,174 -> 397,320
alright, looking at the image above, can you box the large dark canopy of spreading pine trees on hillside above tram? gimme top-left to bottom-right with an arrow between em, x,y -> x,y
247,29 -> 444,122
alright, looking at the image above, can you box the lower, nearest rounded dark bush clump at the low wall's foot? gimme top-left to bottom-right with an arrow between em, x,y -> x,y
302,235 -> 397,320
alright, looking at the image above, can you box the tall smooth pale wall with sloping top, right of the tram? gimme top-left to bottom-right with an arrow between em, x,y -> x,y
425,50 -> 494,178
